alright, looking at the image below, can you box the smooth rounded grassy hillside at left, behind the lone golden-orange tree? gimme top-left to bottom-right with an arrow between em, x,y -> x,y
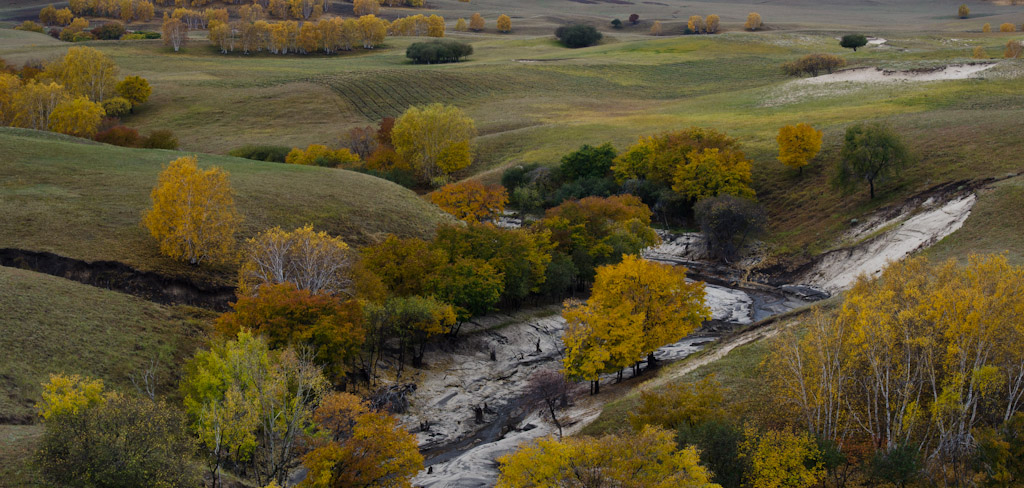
0,128 -> 445,283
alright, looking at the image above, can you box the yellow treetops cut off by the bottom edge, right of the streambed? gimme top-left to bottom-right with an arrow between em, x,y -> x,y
497,426 -> 721,488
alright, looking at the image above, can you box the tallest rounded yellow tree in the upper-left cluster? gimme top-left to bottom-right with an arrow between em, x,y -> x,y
44,46 -> 118,102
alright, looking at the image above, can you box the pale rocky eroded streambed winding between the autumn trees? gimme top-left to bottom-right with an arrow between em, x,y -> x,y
401,235 -> 827,488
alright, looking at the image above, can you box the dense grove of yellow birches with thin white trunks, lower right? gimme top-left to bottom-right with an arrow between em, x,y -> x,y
765,256 -> 1024,486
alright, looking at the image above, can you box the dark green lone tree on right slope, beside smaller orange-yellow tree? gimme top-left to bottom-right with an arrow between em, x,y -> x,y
833,124 -> 912,198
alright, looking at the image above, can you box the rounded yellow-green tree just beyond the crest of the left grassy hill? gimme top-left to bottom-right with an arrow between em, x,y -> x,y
391,103 -> 476,184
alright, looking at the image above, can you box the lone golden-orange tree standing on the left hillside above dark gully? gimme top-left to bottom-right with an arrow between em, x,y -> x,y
142,157 -> 242,265
